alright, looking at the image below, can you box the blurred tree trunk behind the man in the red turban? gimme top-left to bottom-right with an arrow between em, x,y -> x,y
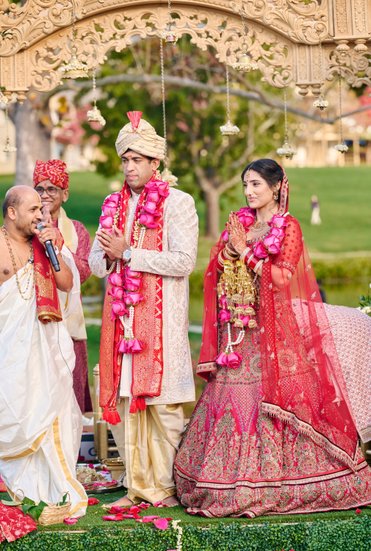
12,100 -> 51,185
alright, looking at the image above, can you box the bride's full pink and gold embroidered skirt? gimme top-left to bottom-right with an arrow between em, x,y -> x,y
175,322 -> 371,517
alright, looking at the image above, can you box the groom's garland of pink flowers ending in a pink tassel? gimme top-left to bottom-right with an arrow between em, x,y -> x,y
99,178 -> 169,354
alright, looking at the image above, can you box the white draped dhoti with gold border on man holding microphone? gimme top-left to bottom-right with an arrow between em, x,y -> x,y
0,268 -> 87,516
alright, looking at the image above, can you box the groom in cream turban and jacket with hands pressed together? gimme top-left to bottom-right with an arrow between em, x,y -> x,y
89,111 -> 198,506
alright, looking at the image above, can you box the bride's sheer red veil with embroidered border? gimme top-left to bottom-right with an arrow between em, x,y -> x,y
197,175 -> 357,468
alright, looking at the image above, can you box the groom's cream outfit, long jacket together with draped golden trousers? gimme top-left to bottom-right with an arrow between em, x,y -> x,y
89,188 -> 198,503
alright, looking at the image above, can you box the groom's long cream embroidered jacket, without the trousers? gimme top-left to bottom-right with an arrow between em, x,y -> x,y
89,188 -> 198,404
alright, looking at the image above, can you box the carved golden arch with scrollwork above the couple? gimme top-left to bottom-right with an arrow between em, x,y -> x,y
0,0 -> 371,101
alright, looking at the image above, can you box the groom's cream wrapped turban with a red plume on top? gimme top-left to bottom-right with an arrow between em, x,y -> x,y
115,111 -> 166,161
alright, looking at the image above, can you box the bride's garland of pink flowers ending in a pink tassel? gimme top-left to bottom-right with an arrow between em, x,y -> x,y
215,207 -> 287,369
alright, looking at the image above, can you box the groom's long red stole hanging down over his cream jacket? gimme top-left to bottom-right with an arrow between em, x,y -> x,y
99,182 -> 164,424
